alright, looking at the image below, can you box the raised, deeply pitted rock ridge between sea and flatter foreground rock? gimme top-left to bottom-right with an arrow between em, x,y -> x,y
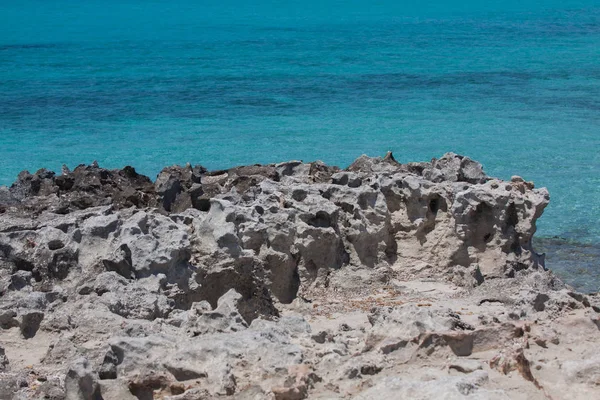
0,154 -> 548,310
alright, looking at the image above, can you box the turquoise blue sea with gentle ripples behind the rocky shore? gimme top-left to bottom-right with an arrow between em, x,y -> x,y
0,0 -> 600,291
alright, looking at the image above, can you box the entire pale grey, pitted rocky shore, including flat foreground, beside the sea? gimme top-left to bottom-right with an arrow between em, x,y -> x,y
0,153 -> 600,400
